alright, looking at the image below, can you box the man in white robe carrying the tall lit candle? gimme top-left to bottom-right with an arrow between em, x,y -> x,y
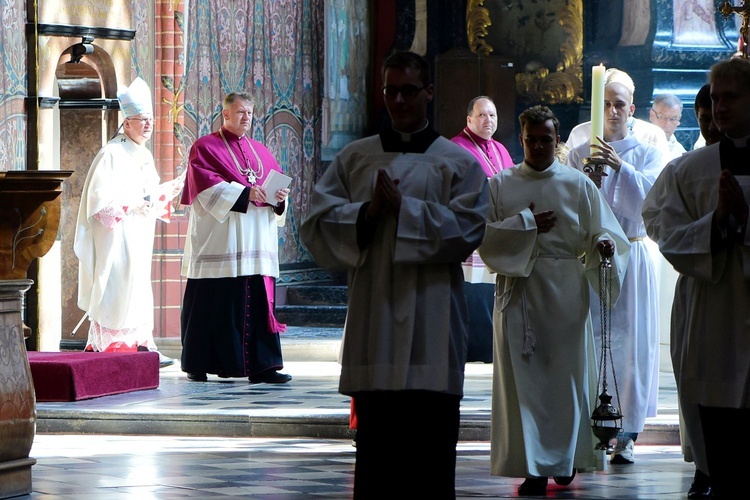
568,82 -> 663,463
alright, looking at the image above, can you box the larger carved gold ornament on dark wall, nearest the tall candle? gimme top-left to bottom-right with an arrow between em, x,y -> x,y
516,0 -> 583,104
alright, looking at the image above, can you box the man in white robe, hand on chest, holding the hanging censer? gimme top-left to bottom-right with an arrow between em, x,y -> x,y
479,106 -> 630,496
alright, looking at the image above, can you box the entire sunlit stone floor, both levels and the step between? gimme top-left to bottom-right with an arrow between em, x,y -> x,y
23,330 -> 693,500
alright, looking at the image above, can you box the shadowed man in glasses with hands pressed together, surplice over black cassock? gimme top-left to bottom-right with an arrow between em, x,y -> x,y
300,52 -> 488,499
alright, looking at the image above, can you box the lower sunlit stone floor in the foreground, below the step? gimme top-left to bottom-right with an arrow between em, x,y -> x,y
26,434 -> 693,500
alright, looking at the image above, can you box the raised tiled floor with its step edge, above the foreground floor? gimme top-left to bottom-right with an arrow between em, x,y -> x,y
37,361 -> 679,445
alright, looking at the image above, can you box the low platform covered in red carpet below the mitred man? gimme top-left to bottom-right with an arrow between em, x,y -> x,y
28,351 -> 159,401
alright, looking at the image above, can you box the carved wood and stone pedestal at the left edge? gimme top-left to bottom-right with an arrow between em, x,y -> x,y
0,170 -> 73,498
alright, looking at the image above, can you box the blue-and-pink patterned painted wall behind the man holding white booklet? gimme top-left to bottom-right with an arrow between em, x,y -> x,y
176,0 -> 324,263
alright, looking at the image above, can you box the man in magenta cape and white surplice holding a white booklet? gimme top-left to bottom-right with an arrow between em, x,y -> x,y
181,92 -> 292,384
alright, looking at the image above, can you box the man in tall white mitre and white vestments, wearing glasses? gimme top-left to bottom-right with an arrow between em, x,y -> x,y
73,78 -> 184,367
